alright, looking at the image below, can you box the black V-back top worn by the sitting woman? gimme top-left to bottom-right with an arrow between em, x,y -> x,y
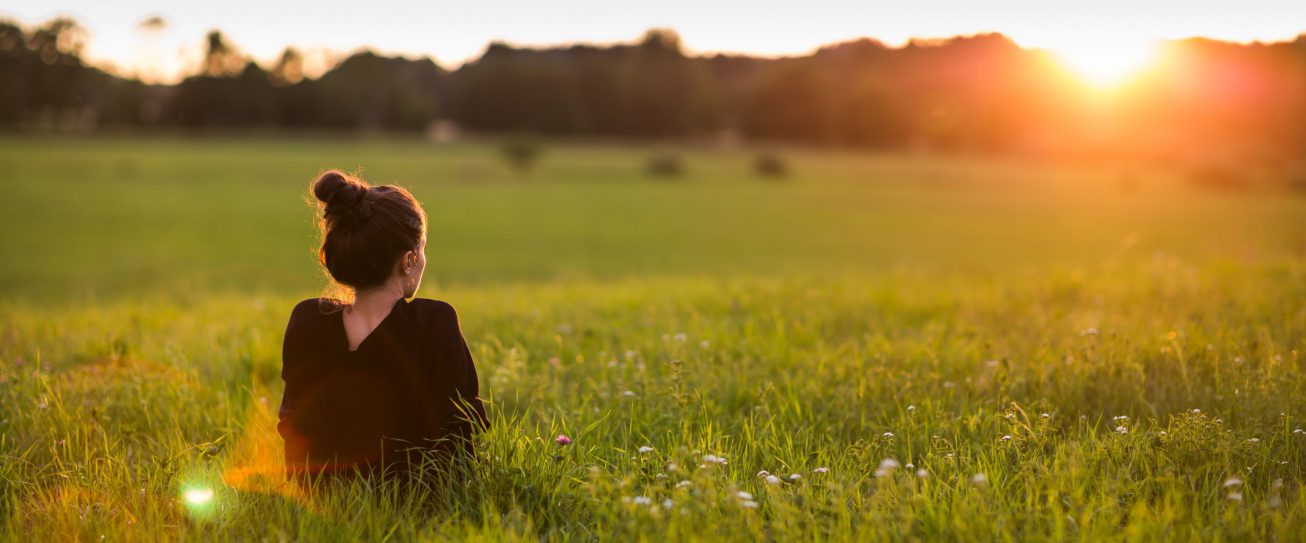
277,298 -> 488,474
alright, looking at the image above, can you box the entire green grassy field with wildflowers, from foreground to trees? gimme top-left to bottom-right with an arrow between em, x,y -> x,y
0,138 -> 1306,540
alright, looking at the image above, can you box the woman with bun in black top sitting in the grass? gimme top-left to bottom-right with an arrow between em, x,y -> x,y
277,171 -> 487,475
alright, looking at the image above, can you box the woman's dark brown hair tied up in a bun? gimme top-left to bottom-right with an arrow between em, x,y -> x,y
312,170 -> 426,297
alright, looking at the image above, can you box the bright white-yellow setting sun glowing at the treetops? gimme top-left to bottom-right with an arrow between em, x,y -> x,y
1049,39 -> 1160,90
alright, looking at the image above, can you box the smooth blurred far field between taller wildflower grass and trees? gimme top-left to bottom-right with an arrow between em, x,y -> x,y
0,133 -> 1306,300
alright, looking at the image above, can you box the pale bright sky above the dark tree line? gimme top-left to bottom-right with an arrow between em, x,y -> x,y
0,0 -> 1306,82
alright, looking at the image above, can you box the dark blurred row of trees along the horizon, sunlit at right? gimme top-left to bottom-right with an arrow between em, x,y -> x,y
0,18 -> 1306,158
